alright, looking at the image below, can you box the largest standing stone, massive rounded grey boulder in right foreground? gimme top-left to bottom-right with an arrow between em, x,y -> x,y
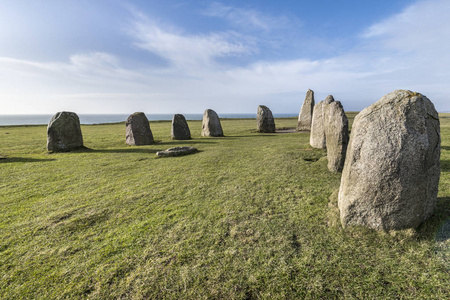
339,90 -> 440,230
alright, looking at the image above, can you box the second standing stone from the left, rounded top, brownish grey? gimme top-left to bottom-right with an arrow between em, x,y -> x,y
125,112 -> 154,146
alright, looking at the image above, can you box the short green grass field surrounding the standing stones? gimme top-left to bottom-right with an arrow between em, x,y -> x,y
0,114 -> 450,299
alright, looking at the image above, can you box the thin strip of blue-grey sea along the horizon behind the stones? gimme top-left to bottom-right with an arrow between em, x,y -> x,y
0,113 -> 297,126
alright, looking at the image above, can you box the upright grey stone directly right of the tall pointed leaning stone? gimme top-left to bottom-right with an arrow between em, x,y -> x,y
309,95 -> 334,149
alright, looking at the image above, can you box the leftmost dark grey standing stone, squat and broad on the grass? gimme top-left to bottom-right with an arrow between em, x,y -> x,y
47,111 -> 83,152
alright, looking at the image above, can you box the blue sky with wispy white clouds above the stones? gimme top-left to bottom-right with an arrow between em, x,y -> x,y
0,0 -> 450,115
